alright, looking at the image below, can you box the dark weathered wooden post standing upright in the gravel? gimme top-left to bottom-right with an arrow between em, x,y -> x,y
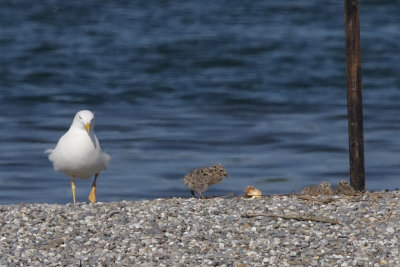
344,0 -> 365,191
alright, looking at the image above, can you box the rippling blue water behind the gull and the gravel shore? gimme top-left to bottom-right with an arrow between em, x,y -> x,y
0,0 -> 400,204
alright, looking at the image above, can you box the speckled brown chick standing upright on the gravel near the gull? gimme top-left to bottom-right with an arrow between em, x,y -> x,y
183,163 -> 229,198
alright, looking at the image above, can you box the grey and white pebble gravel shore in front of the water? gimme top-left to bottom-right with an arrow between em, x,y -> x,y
0,190 -> 400,266
